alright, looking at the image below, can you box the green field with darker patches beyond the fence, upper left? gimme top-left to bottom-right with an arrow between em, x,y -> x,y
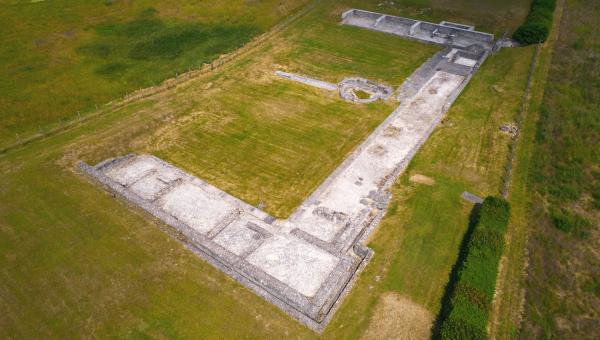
0,0 -> 309,147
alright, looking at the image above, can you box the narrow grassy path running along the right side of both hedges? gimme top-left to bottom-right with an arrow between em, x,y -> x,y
489,0 -> 564,339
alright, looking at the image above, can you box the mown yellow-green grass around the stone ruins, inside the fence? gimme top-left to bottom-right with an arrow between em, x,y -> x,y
0,1 -> 533,338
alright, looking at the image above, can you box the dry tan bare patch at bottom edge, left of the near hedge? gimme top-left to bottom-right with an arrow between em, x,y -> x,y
362,292 -> 433,339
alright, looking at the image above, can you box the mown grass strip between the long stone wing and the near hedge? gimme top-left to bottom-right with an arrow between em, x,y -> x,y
356,48 -> 533,334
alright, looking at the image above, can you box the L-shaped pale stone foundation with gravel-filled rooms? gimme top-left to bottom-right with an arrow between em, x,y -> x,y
79,10 -> 487,332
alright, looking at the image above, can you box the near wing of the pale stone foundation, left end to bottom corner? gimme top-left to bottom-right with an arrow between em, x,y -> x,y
78,155 -> 370,331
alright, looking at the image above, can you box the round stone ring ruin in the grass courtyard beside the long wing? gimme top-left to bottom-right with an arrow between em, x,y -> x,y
338,77 -> 393,103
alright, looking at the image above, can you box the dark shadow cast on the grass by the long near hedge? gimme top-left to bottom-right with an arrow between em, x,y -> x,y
431,203 -> 481,339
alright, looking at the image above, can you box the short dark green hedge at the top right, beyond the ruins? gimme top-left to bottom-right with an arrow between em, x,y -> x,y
513,0 -> 556,44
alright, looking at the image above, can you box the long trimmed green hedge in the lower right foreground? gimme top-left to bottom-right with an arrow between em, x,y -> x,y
440,196 -> 510,340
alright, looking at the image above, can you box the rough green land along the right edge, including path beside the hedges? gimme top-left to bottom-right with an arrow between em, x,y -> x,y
482,1 -> 600,339
